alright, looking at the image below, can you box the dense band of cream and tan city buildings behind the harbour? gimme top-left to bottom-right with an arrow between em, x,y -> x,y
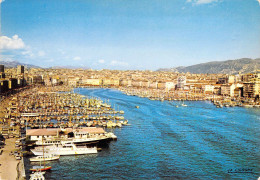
0,65 -> 260,107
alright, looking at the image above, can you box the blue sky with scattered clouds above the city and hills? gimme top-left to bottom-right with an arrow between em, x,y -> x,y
0,0 -> 260,70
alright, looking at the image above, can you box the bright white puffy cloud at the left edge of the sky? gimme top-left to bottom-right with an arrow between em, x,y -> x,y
0,34 -> 25,50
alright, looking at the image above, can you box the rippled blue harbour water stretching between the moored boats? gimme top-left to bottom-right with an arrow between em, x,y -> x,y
23,89 -> 260,180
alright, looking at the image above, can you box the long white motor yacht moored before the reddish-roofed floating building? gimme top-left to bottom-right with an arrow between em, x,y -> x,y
31,143 -> 97,156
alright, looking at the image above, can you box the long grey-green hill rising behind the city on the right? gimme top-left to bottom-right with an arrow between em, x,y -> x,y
157,58 -> 260,74
